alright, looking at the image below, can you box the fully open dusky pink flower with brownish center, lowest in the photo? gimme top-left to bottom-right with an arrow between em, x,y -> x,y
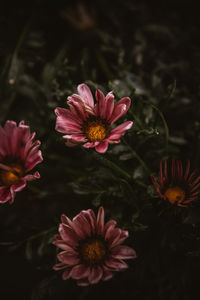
53,207 -> 136,286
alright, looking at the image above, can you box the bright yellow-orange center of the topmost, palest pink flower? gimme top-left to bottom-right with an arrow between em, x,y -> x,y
85,121 -> 107,142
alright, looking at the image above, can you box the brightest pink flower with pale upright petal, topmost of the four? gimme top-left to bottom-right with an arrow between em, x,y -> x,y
55,84 -> 133,153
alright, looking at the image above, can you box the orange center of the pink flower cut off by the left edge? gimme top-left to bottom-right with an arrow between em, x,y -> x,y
0,164 -> 23,186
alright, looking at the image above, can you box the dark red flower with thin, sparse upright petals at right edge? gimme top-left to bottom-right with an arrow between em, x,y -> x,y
151,159 -> 200,206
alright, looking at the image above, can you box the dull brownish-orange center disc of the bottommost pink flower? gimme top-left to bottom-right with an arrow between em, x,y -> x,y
81,239 -> 106,264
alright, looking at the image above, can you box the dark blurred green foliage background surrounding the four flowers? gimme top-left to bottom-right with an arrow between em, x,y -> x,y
0,0 -> 200,300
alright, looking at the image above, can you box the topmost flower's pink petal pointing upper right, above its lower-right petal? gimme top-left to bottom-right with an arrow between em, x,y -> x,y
109,97 -> 131,125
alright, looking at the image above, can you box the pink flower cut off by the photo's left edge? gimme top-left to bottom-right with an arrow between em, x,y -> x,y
0,121 -> 43,203
